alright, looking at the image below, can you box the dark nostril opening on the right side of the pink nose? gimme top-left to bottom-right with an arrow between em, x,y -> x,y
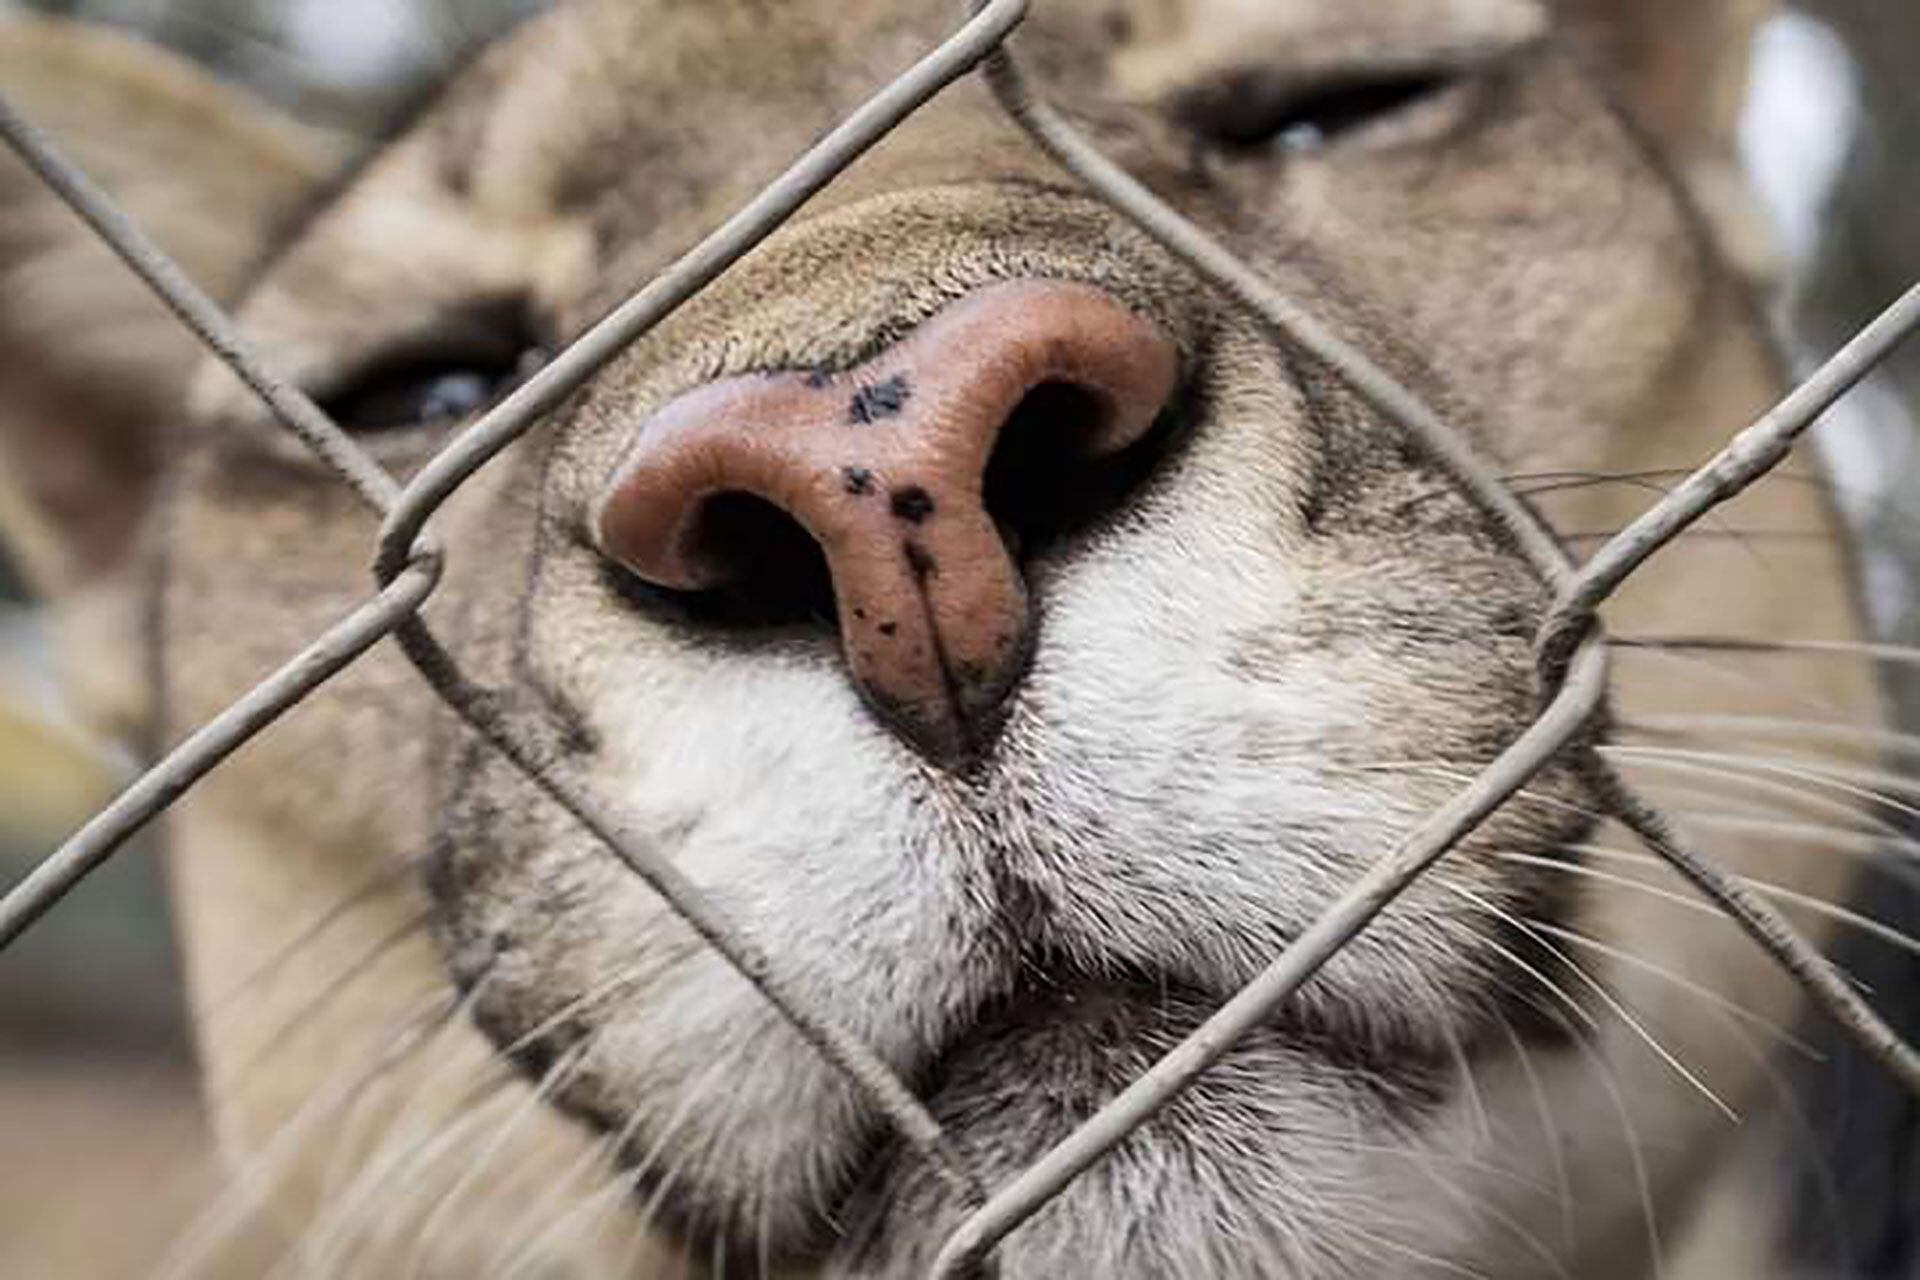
981,382 -> 1173,560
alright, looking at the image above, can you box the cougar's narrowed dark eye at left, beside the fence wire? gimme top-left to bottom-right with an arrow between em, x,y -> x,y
317,305 -> 547,436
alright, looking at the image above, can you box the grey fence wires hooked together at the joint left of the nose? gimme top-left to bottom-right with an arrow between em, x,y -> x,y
0,0 -> 1027,1203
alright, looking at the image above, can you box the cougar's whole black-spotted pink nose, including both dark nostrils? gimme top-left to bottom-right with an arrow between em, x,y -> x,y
593,280 -> 1185,766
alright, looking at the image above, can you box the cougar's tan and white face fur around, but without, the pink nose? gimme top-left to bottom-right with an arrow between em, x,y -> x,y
0,0 -> 1874,1278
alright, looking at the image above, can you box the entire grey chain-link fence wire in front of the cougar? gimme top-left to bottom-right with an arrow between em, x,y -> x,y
0,0 -> 1920,1278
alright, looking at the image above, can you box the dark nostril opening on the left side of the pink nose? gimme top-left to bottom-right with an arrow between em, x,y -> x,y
614,493 -> 837,628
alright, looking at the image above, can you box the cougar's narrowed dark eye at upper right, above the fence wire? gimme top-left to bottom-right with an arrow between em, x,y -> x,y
1175,69 -> 1459,152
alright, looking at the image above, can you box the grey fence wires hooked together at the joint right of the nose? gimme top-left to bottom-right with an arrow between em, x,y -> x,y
933,35 -> 1920,1280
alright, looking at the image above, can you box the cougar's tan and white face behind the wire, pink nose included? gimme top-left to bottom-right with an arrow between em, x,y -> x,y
0,0 -> 1864,1278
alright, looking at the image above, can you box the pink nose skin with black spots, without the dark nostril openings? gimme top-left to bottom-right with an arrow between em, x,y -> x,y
599,280 -> 1179,764
